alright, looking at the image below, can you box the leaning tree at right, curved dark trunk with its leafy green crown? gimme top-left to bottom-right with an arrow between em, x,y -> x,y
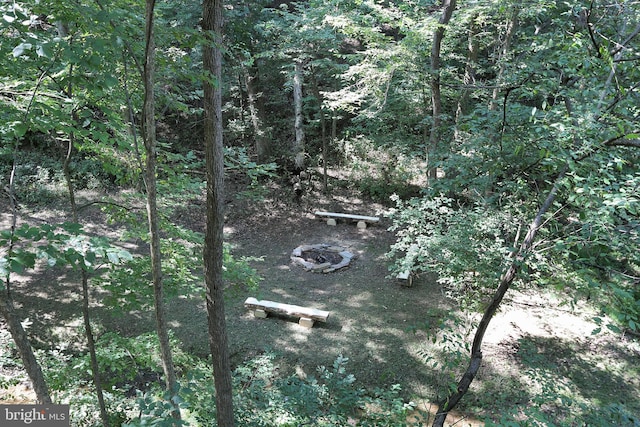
384,0 -> 640,425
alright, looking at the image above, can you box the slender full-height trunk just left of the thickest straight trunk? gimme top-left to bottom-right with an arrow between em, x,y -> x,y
143,0 -> 180,418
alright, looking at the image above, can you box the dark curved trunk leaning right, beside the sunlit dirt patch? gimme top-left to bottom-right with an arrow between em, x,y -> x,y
433,167 -> 568,427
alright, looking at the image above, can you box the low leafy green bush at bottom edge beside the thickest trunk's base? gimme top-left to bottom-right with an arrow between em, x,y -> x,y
178,353 -> 413,427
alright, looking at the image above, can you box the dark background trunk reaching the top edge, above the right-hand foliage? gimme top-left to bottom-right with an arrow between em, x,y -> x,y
426,0 -> 456,180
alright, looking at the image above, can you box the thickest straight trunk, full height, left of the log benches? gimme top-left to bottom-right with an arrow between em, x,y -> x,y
202,0 -> 234,427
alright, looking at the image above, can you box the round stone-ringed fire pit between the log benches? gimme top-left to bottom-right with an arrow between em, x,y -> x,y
291,244 -> 355,273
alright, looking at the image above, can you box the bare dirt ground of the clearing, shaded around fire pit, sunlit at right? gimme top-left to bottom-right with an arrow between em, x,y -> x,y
0,177 -> 640,425
